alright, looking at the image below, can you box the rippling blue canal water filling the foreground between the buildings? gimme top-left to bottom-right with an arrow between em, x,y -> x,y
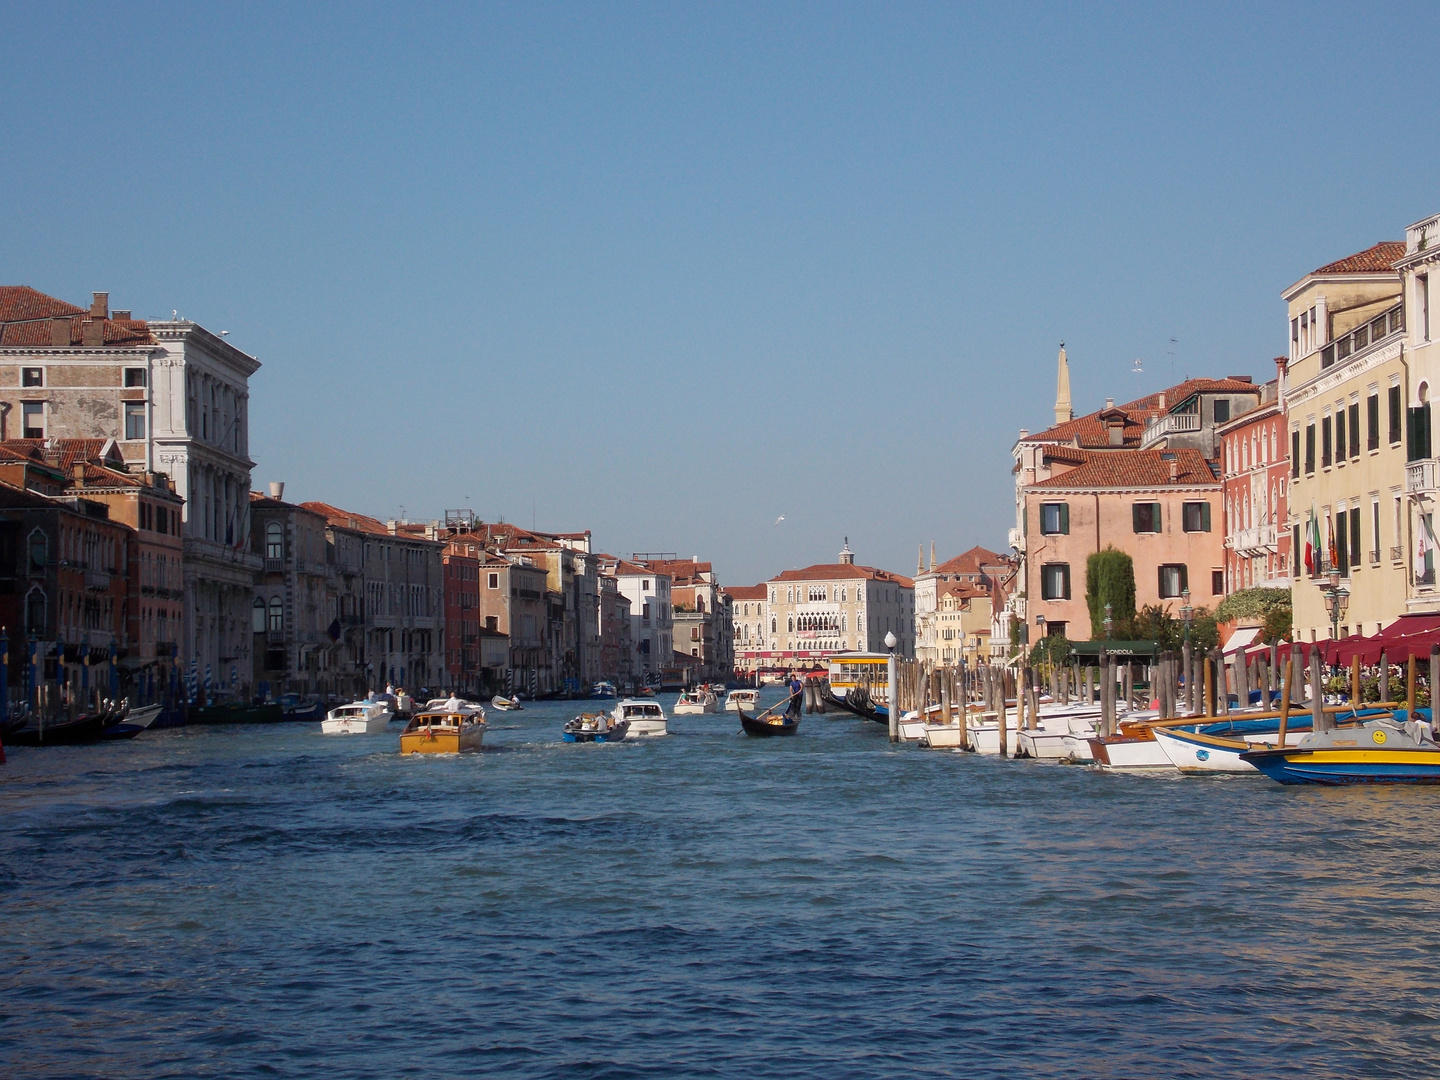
0,691 -> 1440,1080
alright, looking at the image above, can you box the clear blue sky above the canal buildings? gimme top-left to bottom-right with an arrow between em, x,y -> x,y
0,3 -> 1440,585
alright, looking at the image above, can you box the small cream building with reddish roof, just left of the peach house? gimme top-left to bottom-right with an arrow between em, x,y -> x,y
914,543 -> 1015,664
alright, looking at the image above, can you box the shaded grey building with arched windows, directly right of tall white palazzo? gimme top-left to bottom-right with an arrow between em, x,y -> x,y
251,482 -> 338,697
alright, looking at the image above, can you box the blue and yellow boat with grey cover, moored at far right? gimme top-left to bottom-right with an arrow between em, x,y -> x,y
1240,717 -> 1440,785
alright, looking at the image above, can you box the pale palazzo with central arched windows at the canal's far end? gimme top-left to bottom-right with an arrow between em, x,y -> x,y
766,537 -> 914,668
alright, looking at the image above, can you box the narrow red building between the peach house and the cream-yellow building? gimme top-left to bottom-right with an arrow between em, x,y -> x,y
1215,371 -> 1290,593
